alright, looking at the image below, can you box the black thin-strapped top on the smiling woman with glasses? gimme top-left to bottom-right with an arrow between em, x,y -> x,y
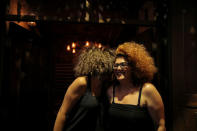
107,88 -> 155,131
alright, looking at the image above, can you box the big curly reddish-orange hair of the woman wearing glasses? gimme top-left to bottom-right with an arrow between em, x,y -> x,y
116,41 -> 157,85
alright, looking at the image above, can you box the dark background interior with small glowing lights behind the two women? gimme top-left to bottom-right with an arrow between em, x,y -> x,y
0,0 -> 197,131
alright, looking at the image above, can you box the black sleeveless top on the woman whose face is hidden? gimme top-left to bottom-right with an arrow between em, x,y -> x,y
64,78 -> 102,131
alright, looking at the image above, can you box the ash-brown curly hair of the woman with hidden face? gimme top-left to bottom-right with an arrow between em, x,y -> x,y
74,46 -> 115,77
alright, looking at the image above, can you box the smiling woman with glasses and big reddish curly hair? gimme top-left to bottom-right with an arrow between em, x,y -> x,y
107,42 -> 165,131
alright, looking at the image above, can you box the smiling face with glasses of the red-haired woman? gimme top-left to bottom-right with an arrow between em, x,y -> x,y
113,57 -> 131,81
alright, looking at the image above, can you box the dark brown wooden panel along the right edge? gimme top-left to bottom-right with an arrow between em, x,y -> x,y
170,0 -> 197,131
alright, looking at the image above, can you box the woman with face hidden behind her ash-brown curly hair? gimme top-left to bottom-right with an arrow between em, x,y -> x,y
54,46 -> 115,131
